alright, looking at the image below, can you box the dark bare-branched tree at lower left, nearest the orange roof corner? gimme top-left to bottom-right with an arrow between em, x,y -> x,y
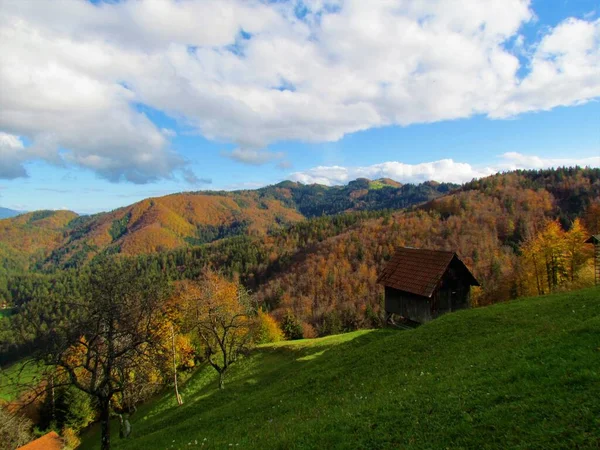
30,259 -> 168,450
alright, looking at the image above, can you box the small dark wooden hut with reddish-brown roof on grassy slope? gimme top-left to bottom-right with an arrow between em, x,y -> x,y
377,248 -> 479,323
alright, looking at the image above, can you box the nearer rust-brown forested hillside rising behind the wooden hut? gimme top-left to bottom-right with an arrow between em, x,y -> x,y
112,169 -> 600,330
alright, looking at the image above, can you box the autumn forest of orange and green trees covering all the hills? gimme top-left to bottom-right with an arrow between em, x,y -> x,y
0,168 -> 600,448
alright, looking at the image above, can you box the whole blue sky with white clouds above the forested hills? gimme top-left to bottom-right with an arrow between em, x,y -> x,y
0,0 -> 600,214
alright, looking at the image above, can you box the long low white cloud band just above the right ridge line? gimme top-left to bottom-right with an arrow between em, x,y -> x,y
290,152 -> 600,186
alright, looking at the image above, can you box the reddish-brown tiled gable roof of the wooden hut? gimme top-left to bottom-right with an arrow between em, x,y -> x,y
377,247 -> 479,297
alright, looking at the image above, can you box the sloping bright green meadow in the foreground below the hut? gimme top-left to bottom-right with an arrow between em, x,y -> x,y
82,288 -> 600,449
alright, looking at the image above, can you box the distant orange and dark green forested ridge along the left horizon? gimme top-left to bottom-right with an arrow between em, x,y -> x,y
0,179 -> 458,270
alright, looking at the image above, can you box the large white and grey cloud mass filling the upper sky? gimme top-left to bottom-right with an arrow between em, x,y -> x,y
0,0 -> 600,179
